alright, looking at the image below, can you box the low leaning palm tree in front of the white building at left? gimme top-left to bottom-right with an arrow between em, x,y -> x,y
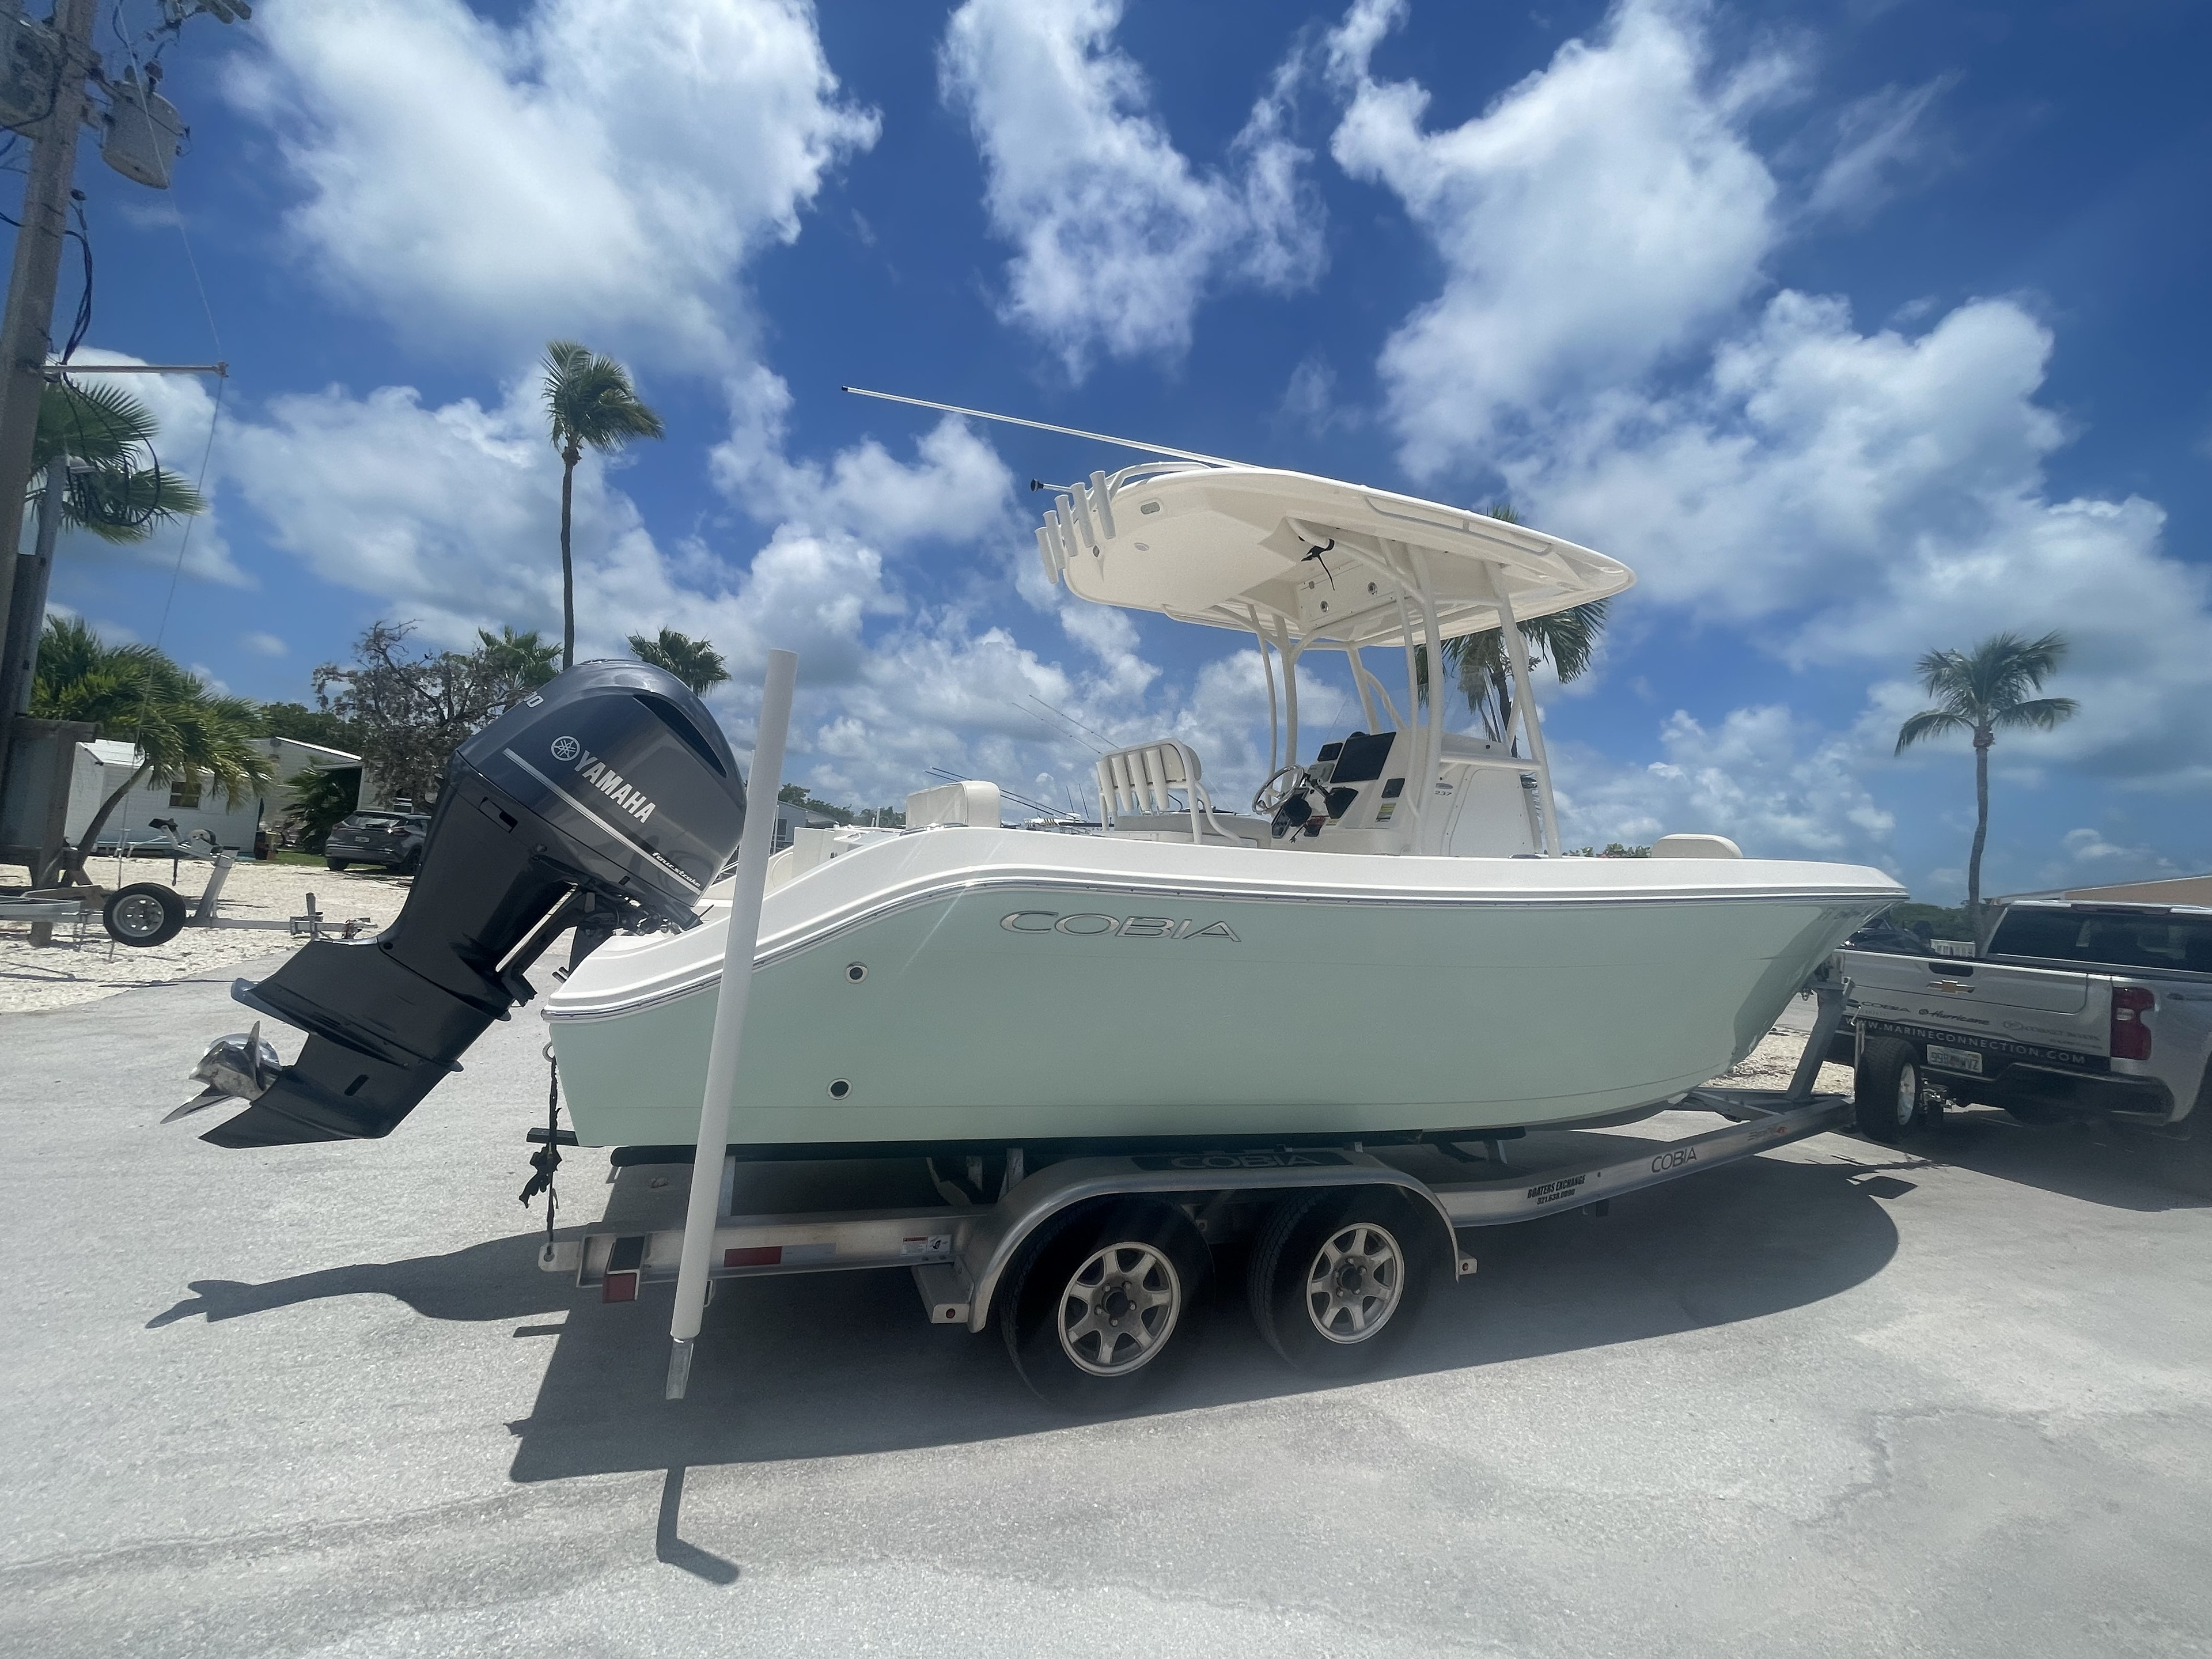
31,617 -> 276,882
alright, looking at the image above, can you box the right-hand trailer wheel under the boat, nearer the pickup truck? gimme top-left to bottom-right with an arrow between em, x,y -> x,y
1245,1190 -> 1438,1376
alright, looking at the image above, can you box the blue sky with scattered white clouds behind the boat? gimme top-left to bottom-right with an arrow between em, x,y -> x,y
35,0 -> 2212,900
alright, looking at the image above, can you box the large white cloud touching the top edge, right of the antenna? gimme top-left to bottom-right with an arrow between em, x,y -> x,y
1330,0 -> 1777,478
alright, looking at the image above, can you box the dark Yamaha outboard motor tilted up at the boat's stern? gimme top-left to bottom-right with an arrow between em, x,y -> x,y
201,661 -> 745,1146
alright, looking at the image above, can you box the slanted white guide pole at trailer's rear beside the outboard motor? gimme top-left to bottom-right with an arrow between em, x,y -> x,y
668,650 -> 798,1400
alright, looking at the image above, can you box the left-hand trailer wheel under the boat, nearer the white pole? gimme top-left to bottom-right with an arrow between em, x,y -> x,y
1000,1199 -> 1214,1414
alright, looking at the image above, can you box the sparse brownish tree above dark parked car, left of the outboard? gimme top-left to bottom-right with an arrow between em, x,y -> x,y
314,622 -> 553,808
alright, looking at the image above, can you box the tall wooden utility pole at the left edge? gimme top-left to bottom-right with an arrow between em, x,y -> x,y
0,0 -> 97,677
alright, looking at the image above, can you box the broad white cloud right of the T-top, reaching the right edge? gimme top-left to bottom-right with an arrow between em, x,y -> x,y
1506,292 -> 2212,787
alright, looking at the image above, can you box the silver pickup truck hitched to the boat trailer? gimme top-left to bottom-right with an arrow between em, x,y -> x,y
1830,898 -> 2212,1141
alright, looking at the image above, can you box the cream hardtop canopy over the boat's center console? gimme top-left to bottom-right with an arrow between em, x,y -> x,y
1037,463 -> 1635,646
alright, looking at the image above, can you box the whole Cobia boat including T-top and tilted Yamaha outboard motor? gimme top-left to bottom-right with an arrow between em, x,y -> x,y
177,438 -> 1902,1154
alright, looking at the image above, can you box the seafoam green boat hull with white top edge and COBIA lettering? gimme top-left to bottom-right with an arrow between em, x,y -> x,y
546,827 -> 1902,1146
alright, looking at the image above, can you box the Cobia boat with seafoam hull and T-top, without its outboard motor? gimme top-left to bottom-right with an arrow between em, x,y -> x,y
544,463 -> 1898,1146
